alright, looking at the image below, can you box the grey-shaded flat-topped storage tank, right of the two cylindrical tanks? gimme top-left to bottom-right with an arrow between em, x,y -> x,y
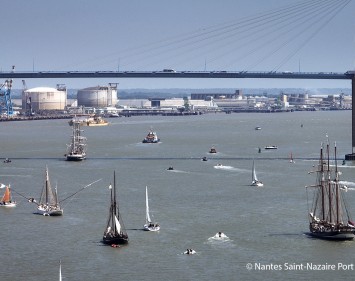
77,83 -> 117,107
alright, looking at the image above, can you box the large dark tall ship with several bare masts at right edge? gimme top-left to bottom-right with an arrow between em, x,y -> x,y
307,142 -> 355,240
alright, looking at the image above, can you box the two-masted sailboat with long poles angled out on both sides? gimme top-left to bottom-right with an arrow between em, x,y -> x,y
31,167 -> 63,216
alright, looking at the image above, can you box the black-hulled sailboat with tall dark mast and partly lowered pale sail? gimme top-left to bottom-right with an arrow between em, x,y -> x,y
102,170 -> 128,246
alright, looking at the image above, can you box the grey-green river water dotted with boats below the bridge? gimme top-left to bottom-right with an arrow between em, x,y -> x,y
0,111 -> 355,281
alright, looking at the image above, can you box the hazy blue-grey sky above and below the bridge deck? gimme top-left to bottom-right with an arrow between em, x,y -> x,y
0,0 -> 355,89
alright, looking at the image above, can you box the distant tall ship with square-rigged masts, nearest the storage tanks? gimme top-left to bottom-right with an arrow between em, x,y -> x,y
64,119 -> 86,161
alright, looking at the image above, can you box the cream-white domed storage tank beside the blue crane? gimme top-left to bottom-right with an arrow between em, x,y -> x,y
22,87 -> 67,111
